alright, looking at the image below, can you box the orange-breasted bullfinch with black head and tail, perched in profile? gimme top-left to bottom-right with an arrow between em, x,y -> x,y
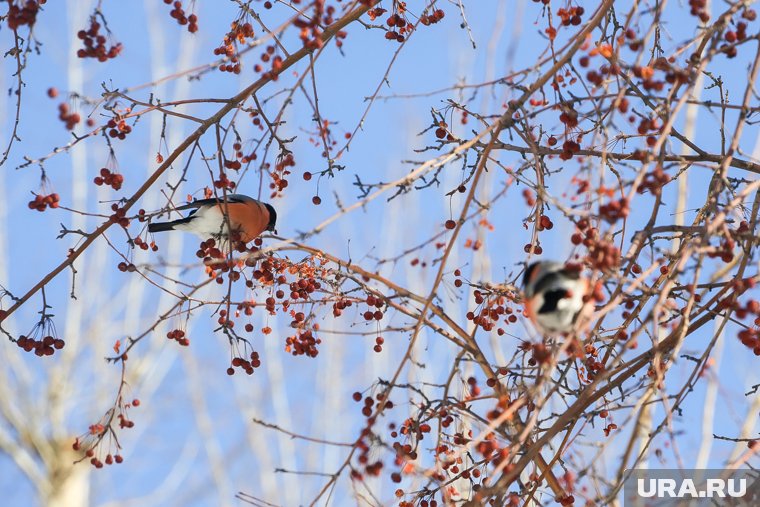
148,194 -> 277,243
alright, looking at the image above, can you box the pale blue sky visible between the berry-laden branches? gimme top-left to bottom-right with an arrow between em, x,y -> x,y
0,0 -> 760,506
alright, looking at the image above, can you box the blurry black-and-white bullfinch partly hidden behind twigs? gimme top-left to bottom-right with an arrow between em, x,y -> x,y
523,261 -> 588,334
